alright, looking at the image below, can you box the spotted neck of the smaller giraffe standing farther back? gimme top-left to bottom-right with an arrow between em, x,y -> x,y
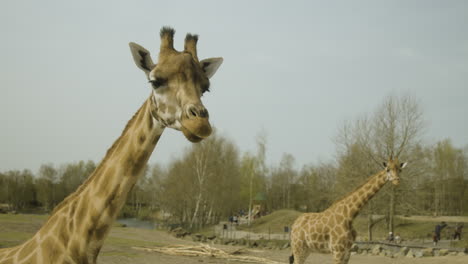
333,170 -> 387,221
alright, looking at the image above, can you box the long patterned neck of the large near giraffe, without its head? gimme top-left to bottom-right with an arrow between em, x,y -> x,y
0,94 -> 164,263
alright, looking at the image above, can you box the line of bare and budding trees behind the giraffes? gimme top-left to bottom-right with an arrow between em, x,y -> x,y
0,96 -> 468,232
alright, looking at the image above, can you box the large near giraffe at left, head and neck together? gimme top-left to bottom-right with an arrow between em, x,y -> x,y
0,27 -> 223,264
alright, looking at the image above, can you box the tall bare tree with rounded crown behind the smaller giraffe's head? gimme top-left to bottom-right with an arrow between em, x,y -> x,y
337,95 -> 425,235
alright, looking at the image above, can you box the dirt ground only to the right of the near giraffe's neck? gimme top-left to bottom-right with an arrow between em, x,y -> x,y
98,228 -> 468,264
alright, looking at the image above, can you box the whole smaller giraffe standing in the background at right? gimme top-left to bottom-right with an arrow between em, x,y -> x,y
289,158 -> 406,264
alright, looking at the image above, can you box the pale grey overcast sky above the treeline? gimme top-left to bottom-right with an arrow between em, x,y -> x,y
0,0 -> 468,172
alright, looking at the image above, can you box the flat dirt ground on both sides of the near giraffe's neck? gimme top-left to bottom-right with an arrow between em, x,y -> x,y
0,215 -> 468,264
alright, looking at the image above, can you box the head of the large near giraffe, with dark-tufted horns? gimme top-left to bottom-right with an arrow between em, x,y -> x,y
130,27 -> 223,142
